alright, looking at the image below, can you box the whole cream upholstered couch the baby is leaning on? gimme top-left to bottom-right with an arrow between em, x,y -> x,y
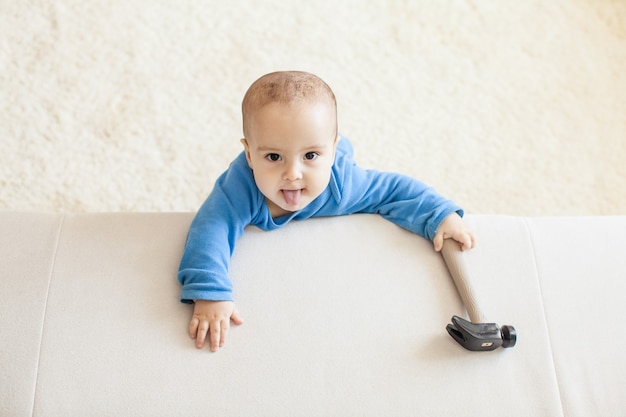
0,212 -> 626,417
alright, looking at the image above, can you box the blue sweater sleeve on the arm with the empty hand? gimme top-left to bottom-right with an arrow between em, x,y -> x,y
178,154 -> 258,303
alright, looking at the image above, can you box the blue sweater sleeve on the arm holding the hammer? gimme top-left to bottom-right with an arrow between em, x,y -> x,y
333,139 -> 463,240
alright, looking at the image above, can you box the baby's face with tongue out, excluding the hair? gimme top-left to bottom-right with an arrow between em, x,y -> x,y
242,103 -> 338,217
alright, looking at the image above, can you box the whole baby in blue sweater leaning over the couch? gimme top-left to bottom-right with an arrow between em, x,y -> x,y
178,71 -> 474,351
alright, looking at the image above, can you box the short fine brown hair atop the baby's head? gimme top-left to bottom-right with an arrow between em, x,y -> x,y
241,71 -> 337,137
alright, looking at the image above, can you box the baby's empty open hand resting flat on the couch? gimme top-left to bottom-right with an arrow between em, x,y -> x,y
189,300 -> 243,352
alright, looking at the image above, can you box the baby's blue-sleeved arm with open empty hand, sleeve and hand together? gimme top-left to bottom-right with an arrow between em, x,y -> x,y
178,153 -> 258,351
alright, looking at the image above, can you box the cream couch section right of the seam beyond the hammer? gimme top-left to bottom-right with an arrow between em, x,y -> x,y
530,217 -> 626,417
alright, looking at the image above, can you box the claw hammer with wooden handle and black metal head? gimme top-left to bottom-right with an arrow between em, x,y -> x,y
441,239 -> 517,352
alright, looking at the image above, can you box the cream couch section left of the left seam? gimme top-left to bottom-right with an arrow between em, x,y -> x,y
0,213 -> 62,416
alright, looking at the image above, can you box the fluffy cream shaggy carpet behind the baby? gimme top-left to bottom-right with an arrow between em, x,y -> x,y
0,0 -> 626,215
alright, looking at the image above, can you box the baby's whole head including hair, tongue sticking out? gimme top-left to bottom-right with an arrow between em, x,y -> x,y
242,71 -> 338,217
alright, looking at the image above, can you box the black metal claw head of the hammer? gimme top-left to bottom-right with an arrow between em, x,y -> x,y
446,316 -> 517,352
